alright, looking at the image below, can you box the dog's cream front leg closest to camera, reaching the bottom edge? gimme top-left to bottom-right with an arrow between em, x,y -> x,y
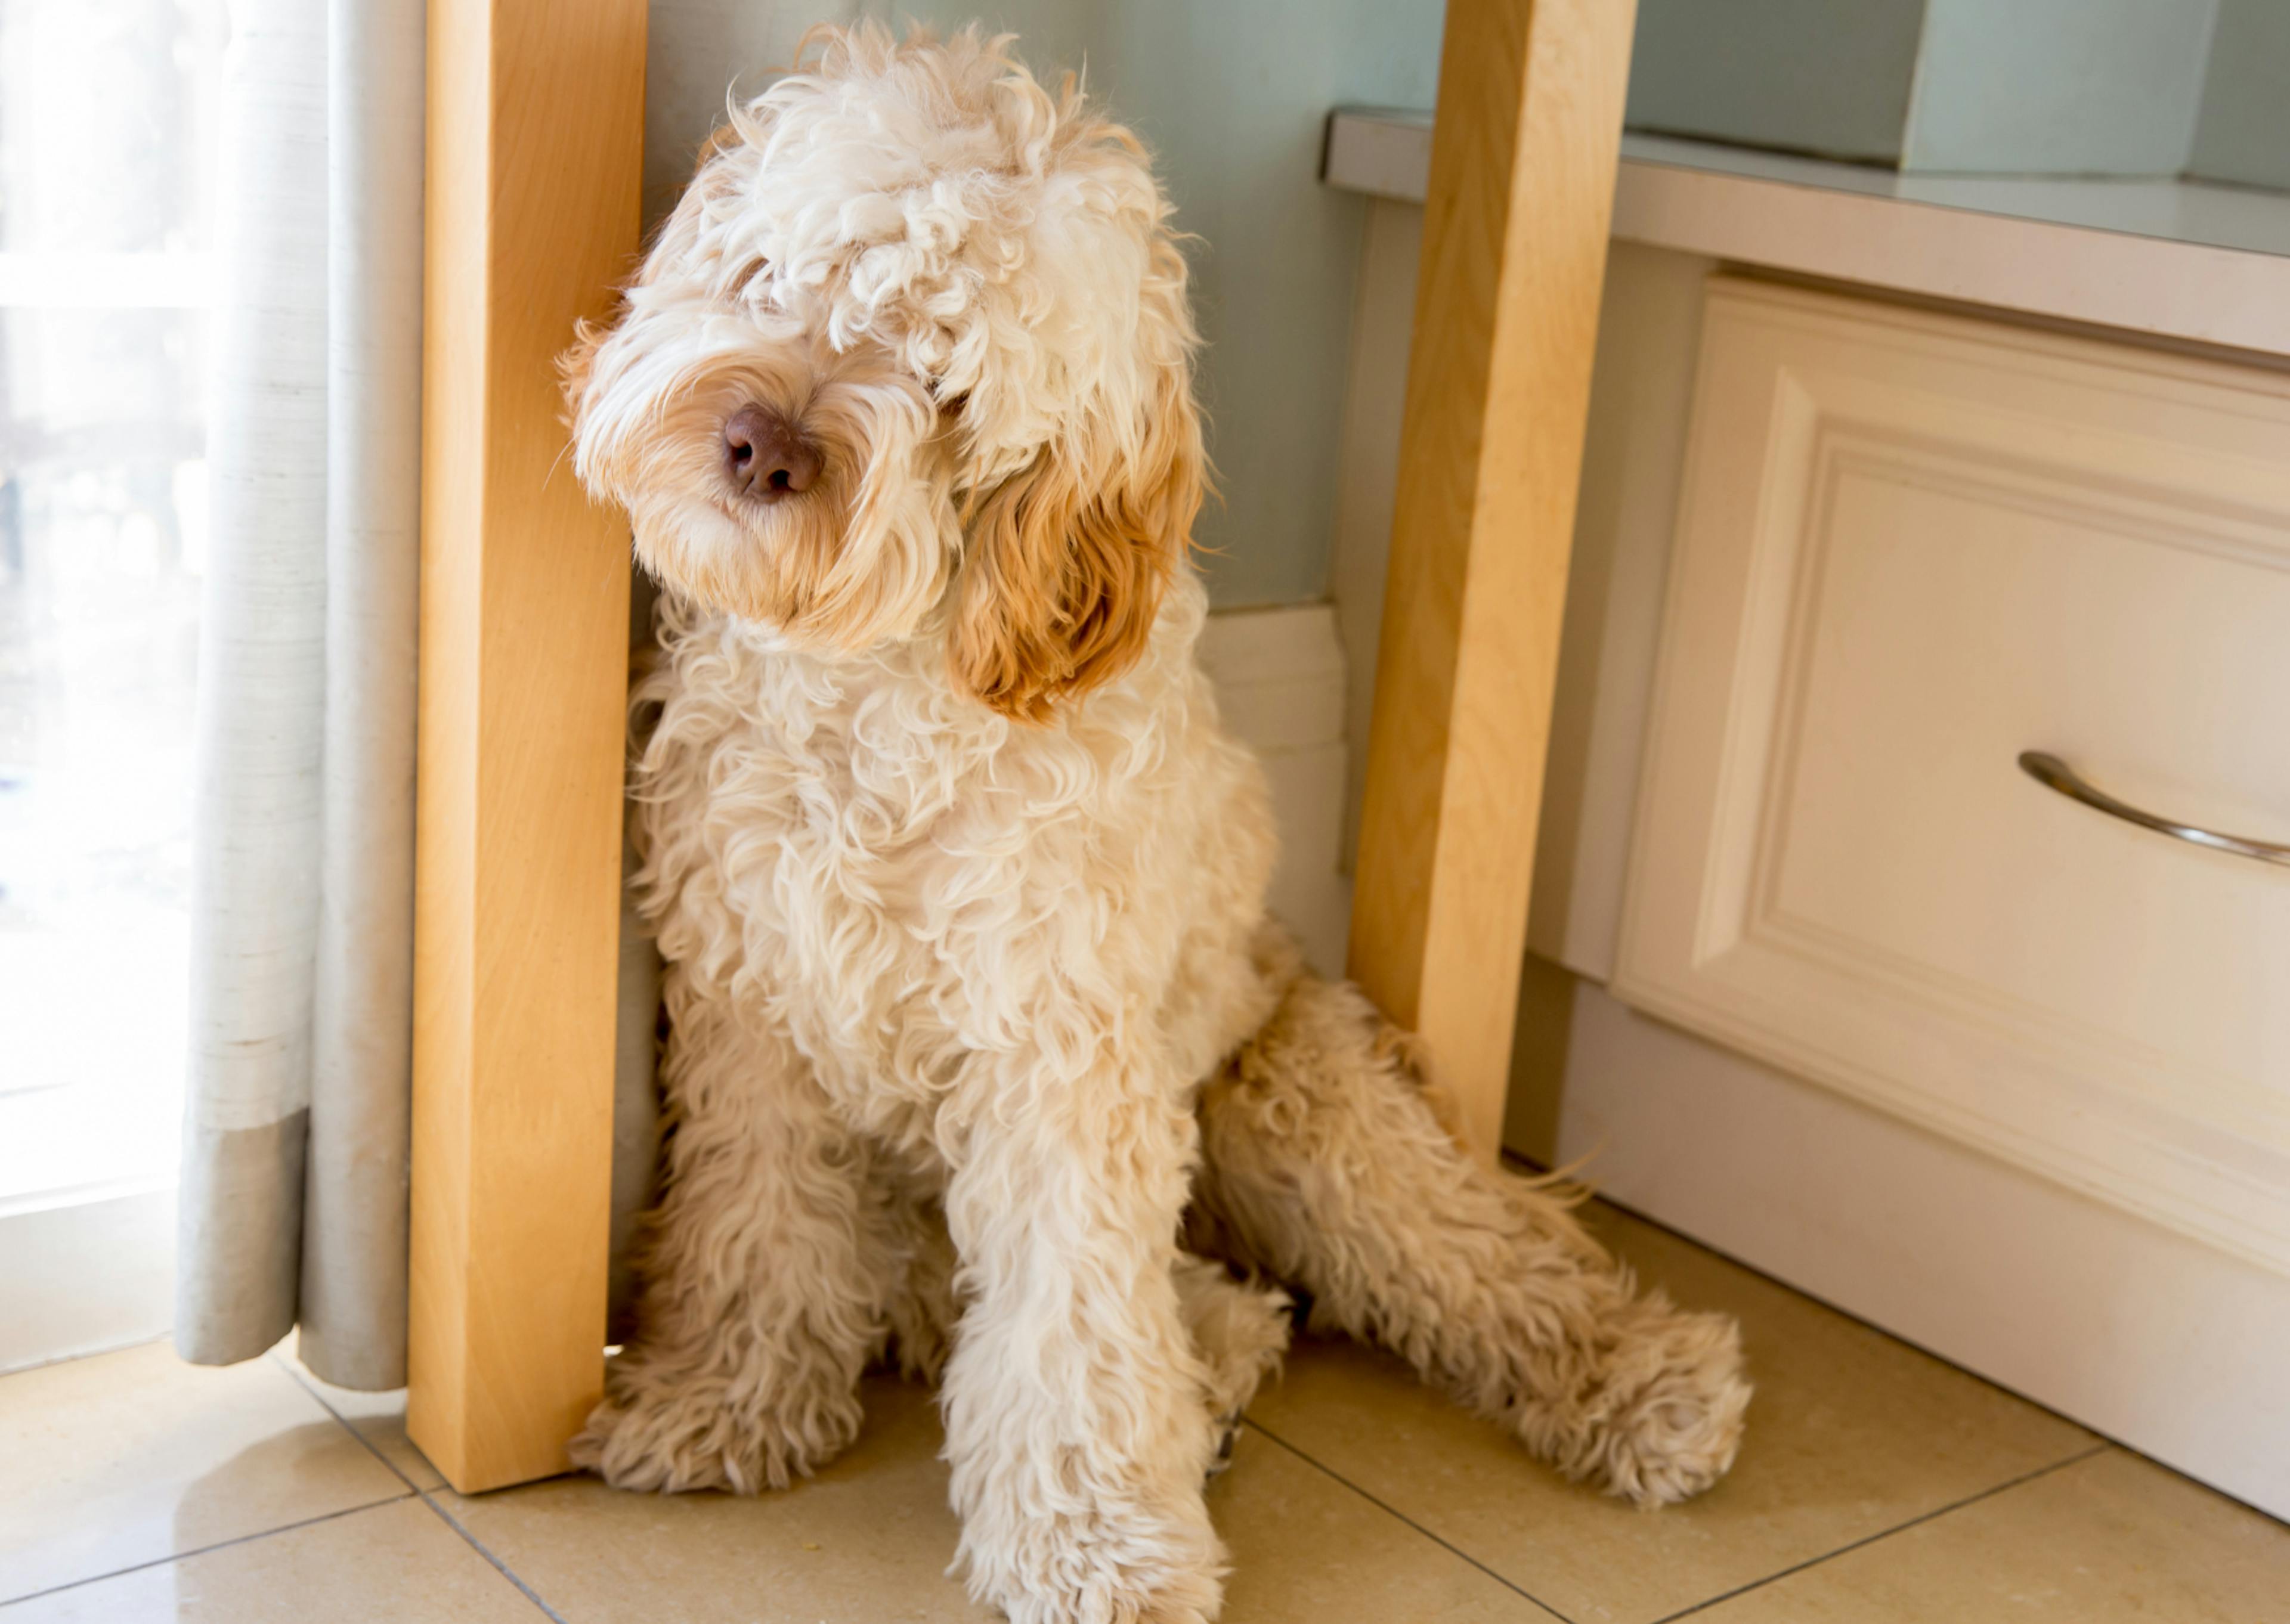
946,1053 -> 1223,1624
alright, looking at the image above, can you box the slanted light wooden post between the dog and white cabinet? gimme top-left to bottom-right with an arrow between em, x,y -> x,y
1351,0 -> 1633,1159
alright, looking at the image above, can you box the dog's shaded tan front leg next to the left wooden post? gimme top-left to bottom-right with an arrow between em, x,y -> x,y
572,969 -> 895,1493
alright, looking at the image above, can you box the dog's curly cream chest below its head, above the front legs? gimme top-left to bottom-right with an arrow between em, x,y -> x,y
639,637 -> 1197,1097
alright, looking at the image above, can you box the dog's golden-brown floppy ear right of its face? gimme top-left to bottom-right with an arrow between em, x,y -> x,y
948,336 -> 1205,721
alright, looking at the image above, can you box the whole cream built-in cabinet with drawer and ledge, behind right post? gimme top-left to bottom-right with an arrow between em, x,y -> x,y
1338,177 -> 2290,1516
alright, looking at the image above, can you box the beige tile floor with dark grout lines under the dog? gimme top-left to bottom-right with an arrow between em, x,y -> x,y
0,1210 -> 2290,1624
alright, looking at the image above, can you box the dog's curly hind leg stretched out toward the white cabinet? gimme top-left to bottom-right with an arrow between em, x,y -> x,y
1193,962 -> 1750,1505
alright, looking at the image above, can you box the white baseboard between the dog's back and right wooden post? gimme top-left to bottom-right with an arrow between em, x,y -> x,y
1200,602 -> 1351,976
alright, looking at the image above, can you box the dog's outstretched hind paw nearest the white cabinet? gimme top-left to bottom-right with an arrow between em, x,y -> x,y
1562,1292 -> 1750,1505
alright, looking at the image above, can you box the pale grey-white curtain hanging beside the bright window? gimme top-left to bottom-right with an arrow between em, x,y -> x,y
177,0 -> 423,1388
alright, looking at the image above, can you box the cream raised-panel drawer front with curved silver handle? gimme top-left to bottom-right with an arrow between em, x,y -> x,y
1612,277 -> 2290,1271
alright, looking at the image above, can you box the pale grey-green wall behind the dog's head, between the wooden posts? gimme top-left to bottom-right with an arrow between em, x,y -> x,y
646,0 -> 1443,607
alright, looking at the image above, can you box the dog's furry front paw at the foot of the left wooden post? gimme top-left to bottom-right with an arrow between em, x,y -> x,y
570,1365 -> 861,1493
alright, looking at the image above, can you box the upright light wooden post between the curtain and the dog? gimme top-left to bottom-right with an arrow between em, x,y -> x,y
408,0 -> 646,1491
